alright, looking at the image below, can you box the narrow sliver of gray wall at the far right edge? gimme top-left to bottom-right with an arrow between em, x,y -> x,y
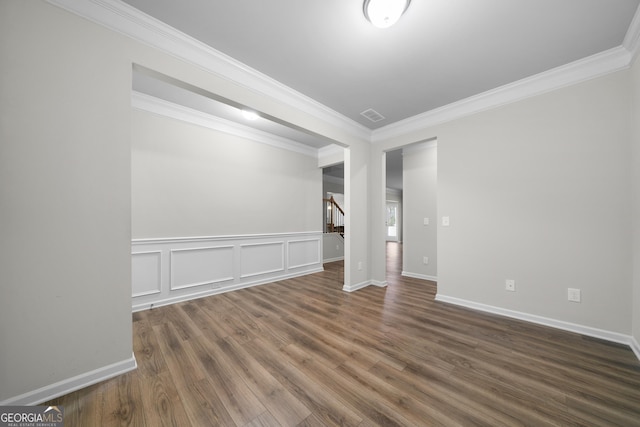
632,53 -> 640,352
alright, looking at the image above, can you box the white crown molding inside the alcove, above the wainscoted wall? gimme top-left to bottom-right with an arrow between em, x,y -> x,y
131,91 -> 318,158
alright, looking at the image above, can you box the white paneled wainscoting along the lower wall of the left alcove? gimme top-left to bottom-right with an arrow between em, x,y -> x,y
131,231 -> 323,311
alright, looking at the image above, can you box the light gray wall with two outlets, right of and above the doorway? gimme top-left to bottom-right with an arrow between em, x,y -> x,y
372,71 -> 632,335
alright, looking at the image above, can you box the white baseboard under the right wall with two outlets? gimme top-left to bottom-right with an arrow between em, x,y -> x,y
436,294 -> 640,360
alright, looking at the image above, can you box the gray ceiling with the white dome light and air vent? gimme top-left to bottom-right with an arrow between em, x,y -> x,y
124,0 -> 640,130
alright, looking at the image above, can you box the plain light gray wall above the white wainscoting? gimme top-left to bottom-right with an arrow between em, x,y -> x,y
131,110 -> 322,239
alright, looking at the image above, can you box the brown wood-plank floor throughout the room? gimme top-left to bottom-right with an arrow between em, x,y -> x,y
47,243 -> 640,427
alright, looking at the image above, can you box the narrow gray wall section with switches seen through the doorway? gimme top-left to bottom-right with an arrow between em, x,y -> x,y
402,141 -> 438,280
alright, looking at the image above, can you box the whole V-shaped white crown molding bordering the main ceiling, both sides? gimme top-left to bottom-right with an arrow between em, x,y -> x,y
46,0 -> 640,147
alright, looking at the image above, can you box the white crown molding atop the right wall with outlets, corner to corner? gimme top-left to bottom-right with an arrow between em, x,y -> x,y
371,46 -> 631,143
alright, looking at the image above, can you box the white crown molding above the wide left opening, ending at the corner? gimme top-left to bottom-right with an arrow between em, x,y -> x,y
46,0 -> 371,141
